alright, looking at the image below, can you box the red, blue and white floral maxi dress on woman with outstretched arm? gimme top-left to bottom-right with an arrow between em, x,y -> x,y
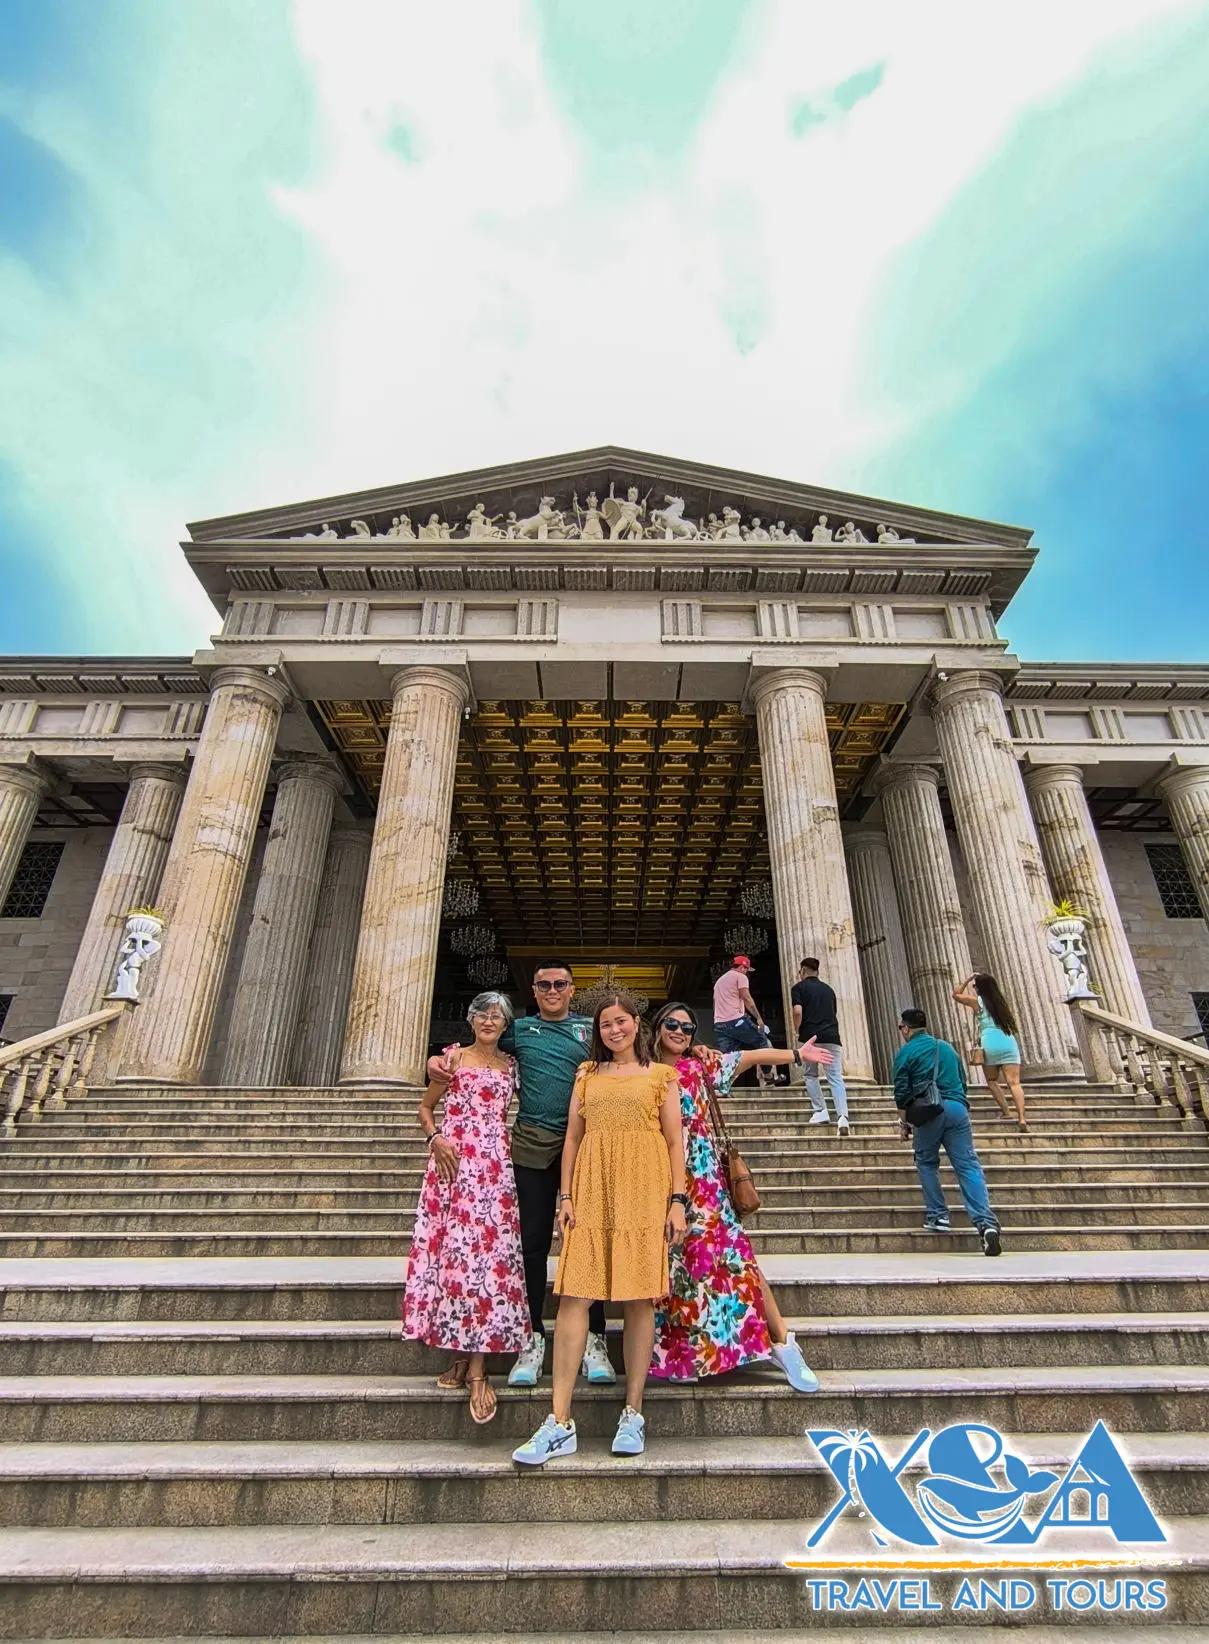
650,1054 -> 771,1378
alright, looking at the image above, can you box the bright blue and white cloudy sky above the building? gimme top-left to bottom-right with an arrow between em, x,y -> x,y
0,0 -> 1209,661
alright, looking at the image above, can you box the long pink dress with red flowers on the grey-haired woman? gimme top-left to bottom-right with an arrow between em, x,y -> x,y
403,1067 -> 530,1353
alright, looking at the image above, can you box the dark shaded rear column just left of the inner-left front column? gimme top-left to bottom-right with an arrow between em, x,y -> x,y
290,827 -> 370,1085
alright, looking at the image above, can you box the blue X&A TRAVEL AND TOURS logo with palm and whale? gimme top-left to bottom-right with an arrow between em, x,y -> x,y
785,1422 -> 1166,1613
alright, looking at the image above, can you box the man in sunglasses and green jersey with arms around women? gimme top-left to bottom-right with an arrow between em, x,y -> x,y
428,958 -> 617,1388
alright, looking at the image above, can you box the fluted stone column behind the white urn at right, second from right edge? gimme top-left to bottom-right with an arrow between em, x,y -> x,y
1025,764 -> 1150,1028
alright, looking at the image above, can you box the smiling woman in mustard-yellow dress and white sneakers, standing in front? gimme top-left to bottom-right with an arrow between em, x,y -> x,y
512,993 -> 688,1466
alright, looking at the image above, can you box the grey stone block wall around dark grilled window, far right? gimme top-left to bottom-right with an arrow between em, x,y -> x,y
1092,832 -> 1209,1036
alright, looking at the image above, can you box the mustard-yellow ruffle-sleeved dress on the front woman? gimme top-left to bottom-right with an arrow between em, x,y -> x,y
554,1062 -> 679,1302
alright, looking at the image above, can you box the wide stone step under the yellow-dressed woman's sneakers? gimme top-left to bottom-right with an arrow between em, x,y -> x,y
0,1415 -> 1209,1529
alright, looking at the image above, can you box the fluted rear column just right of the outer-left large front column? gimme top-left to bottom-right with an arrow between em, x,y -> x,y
220,756 -> 340,1087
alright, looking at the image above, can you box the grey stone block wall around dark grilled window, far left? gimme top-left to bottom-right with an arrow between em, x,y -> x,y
0,827 -> 113,1039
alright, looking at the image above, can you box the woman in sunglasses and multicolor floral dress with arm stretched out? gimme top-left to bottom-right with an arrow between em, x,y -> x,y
650,1003 -> 831,1392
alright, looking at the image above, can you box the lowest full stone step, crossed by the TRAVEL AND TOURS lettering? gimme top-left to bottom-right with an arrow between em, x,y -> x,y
0,1519 -> 1209,1639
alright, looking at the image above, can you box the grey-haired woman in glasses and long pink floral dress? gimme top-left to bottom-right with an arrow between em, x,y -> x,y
403,993 -> 530,1424
